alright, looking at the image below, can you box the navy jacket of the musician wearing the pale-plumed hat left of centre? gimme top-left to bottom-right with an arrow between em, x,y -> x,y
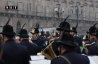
32,36 -> 45,51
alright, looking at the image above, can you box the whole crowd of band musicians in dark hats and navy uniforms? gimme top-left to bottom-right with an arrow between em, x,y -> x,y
0,18 -> 98,64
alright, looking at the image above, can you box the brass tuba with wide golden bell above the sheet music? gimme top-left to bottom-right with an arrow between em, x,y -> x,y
41,39 -> 56,60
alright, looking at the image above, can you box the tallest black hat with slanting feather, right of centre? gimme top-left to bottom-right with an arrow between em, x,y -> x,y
56,16 -> 70,32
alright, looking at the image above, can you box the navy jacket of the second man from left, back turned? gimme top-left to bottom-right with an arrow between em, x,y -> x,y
20,39 -> 39,55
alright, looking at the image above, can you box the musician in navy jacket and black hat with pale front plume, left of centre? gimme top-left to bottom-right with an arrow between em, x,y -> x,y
31,28 -> 46,51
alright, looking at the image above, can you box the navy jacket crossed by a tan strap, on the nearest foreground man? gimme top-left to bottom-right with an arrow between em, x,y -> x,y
51,52 -> 90,64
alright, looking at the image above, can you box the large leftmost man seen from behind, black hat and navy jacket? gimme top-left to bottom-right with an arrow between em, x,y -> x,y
1,24 -> 30,64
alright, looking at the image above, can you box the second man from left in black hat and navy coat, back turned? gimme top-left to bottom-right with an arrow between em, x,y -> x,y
18,29 -> 39,55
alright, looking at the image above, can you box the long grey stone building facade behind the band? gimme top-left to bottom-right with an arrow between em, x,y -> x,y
0,0 -> 98,34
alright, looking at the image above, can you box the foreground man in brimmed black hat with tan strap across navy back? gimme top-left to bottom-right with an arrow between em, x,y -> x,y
51,33 -> 90,64
